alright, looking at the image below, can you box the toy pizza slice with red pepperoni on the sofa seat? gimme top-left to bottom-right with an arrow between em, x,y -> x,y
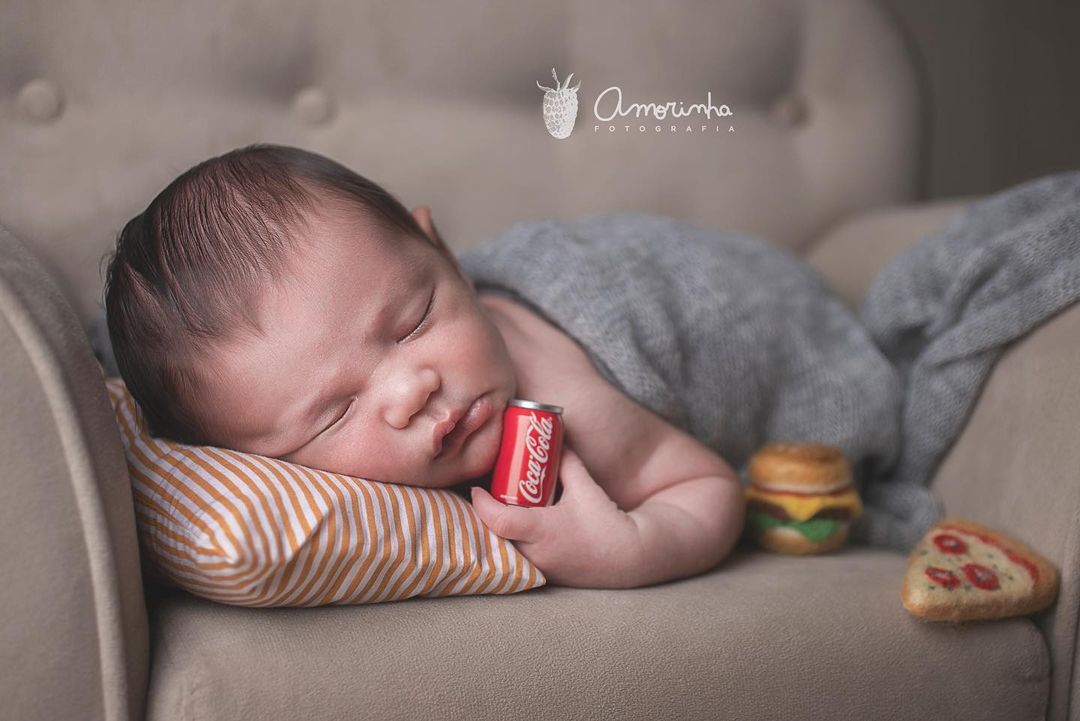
901,518 -> 1058,623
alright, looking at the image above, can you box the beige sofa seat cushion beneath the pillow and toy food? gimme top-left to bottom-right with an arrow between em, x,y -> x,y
148,546 -> 1050,721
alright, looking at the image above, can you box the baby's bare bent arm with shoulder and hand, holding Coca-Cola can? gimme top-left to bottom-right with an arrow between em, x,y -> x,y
473,358 -> 744,588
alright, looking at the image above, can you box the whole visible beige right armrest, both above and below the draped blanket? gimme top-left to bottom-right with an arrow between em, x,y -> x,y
807,201 -> 1080,719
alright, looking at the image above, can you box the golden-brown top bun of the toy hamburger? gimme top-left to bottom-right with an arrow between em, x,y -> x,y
747,443 -> 851,493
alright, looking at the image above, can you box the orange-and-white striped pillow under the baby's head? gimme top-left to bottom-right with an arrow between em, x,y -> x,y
105,378 -> 545,607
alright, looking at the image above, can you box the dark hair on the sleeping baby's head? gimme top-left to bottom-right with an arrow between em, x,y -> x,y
105,144 -> 424,445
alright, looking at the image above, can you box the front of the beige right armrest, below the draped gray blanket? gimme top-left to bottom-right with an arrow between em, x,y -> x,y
933,297 -> 1080,719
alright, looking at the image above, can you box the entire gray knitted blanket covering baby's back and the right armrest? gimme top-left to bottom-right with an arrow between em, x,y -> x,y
459,173 -> 1080,552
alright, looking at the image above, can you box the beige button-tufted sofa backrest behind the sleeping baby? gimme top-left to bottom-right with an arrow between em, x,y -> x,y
0,0 -> 918,319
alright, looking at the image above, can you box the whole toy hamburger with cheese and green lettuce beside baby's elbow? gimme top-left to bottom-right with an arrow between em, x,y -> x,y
746,443 -> 863,555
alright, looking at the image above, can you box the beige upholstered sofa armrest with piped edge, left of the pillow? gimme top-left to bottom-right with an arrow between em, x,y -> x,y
0,227 -> 149,721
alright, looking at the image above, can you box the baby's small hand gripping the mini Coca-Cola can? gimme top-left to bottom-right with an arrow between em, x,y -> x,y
472,447 -> 638,588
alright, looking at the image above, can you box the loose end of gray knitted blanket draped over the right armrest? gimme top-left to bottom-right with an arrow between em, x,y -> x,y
853,172 -> 1080,548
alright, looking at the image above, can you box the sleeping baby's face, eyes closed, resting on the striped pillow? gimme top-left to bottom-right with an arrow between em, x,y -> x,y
199,199 -> 516,487
